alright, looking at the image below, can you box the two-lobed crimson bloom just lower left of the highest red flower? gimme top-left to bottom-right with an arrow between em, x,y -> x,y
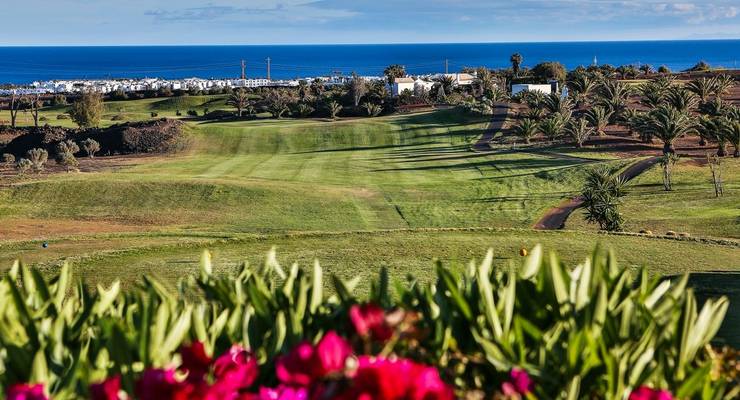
275,331 -> 352,386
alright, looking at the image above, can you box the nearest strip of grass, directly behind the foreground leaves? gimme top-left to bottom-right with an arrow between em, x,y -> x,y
0,230 -> 740,286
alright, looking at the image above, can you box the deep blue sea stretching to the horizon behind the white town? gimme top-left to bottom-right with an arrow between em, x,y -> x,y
0,40 -> 740,84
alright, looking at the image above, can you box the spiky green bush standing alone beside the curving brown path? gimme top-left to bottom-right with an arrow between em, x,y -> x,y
581,168 -> 626,232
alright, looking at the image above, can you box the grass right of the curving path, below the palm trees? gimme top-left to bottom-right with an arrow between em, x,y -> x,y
566,157 -> 740,239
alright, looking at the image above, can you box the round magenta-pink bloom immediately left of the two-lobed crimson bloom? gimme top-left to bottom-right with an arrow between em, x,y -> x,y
213,345 -> 259,391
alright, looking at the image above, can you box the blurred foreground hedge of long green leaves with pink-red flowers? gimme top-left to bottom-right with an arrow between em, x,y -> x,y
0,246 -> 740,399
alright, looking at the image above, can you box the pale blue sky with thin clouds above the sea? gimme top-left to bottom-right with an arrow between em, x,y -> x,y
0,0 -> 740,46
